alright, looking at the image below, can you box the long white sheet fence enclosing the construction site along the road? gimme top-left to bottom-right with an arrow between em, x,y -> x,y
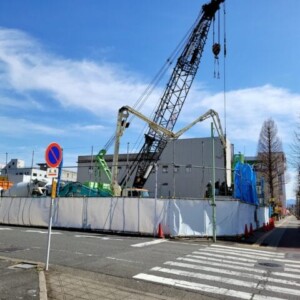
0,197 -> 268,237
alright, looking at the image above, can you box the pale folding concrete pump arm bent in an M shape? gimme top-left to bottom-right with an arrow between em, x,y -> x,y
111,106 -> 228,196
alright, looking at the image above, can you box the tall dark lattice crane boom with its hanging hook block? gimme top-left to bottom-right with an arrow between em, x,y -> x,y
120,0 -> 225,188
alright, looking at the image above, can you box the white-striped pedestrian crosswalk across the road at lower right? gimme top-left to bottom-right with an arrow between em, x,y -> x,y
133,244 -> 300,300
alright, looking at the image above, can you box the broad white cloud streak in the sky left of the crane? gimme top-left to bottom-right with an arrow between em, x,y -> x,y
0,28 -> 152,117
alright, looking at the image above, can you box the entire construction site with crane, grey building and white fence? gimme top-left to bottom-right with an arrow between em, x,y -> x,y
0,0 -> 285,239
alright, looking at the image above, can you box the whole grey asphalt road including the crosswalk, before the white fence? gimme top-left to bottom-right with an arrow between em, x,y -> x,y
0,217 -> 300,300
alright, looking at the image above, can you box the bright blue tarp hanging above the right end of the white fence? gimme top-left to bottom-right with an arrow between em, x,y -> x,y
233,162 -> 259,205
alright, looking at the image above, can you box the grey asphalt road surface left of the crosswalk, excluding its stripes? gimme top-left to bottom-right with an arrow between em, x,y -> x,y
0,226 -> 208,277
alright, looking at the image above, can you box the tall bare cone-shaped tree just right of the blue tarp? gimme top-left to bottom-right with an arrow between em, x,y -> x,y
257,118 -> 285,198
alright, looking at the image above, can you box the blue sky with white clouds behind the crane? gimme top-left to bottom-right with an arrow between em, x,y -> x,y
0,0 -> 300,198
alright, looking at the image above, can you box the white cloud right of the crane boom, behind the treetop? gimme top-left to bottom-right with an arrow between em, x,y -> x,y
182,85 -> 300,155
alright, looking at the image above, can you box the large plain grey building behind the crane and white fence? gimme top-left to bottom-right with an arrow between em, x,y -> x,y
78,138 -> 232,198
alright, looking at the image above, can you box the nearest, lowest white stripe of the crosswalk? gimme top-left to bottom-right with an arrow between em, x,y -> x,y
133,273 -> 262,300
